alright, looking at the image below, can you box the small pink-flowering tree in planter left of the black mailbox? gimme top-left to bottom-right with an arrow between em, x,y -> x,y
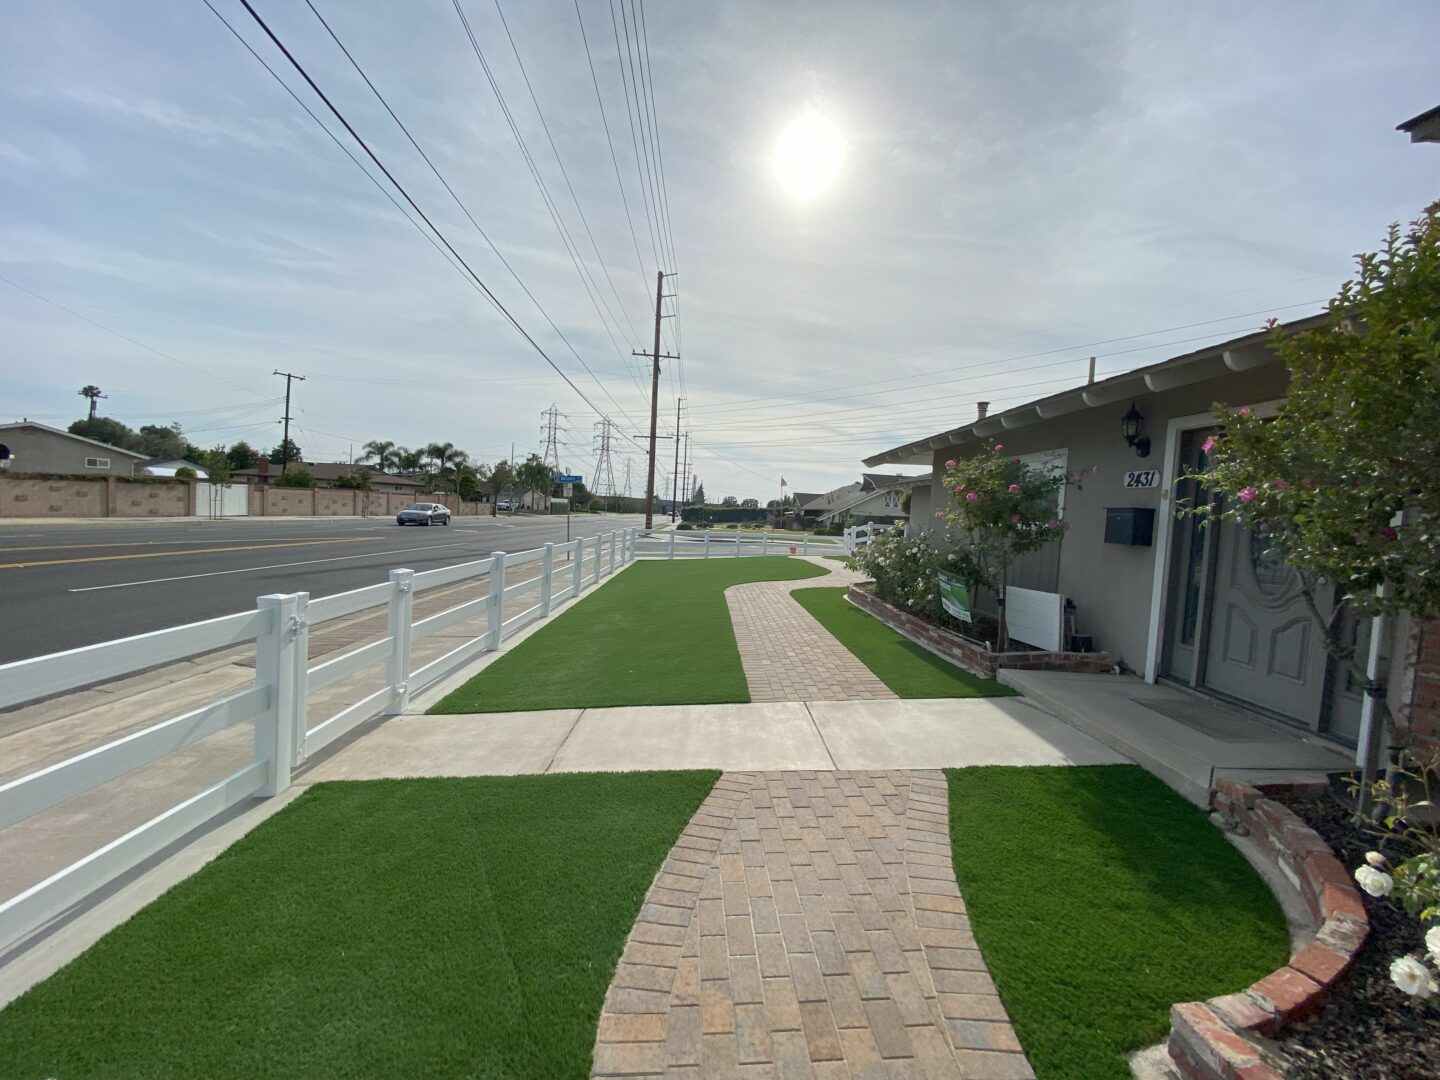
942,442 -> 1067,649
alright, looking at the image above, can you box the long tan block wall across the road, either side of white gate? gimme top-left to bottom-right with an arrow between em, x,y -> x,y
0,475 -> 494,518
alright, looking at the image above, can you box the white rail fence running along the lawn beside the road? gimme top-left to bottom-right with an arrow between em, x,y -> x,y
0,528 -> 847,950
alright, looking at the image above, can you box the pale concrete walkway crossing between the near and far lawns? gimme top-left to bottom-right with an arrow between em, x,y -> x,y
298,697 -> 1129,783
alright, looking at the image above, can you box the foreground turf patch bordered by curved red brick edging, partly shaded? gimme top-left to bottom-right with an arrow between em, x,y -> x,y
946,765 -> 1290,1080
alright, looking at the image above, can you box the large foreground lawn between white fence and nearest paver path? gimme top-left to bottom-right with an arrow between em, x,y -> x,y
0,772 -> 719,1080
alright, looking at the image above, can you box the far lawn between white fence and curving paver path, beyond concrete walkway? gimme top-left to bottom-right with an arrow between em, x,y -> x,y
431,556 -> 825,713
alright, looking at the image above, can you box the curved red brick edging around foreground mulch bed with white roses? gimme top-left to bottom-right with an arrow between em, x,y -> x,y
1168,780 -> 1369,1080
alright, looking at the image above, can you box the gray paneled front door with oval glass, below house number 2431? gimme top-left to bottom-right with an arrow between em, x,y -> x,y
1202,521 -> 1328,727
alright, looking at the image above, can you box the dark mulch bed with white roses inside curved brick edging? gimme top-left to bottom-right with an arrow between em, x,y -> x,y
1280,795 -> 1440,1080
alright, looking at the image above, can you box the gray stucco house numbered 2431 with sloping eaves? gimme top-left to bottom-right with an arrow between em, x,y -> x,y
865,317 -> 1410,746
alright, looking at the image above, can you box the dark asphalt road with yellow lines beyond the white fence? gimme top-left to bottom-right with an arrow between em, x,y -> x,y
0,514 -> 644,664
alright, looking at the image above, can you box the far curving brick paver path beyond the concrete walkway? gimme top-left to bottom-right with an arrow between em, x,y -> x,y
724,559 -> 894,701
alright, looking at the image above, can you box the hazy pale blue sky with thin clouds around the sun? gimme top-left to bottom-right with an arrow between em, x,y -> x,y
0,0 -> 1440,500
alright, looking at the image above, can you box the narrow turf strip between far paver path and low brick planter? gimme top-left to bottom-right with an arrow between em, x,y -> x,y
791,589 -> 1015,697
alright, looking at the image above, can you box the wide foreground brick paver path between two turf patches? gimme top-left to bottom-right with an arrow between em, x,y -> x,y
593,770 -> 1034,1080
